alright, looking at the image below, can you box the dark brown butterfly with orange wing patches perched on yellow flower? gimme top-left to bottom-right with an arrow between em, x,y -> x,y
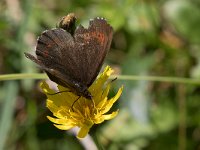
25,13 -> 113,99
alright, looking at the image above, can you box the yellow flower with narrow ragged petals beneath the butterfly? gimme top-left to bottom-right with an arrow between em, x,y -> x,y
40,66 -> 123,138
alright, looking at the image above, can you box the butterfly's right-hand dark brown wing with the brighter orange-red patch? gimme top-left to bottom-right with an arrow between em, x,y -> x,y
70,18 -> 113,87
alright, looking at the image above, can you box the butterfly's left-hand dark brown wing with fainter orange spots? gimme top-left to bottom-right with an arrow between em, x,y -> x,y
25,28 -> 83,91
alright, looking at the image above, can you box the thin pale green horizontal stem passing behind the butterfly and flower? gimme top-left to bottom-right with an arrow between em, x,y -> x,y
0,73 -> 200,85
